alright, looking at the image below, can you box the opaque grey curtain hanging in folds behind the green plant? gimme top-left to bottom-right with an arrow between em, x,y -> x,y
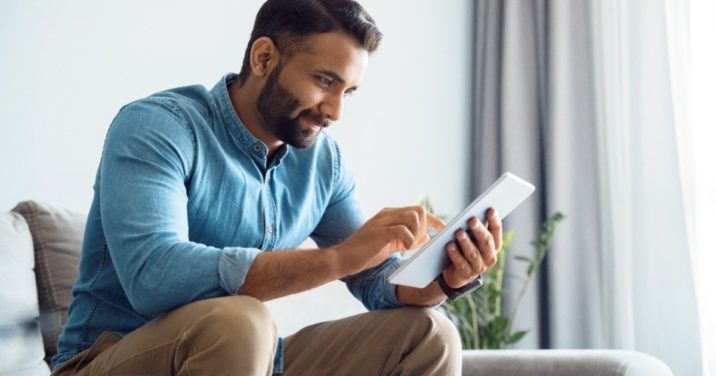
471,0 -> 604,348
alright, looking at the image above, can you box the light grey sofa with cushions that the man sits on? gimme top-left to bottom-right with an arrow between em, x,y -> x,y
0,201 -> 672,376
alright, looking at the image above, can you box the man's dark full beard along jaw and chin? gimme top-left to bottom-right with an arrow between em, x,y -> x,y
256,64 -> 330,148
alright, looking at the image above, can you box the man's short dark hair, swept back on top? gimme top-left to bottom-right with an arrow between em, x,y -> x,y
239,0 -> 383,83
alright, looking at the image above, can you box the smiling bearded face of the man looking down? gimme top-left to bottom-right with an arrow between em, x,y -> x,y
257,32 -> 368,148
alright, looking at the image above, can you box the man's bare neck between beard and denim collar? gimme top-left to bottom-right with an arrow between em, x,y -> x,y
228,78 -> 283,161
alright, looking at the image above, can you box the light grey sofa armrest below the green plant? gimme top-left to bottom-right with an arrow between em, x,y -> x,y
463,350 -> 673,376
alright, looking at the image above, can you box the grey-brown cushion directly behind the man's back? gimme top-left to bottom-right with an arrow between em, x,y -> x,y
13,201 -> 86,361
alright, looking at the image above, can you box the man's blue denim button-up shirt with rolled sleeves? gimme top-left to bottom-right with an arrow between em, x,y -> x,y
53,74 -> 400,373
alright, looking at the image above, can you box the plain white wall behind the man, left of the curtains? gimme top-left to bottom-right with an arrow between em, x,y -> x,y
0,0 -> 471,334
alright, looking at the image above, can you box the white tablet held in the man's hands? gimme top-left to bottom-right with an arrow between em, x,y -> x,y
388,172 -> 535,288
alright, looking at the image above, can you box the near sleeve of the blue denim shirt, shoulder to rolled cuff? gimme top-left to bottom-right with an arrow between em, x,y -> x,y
95,100 -> 260,318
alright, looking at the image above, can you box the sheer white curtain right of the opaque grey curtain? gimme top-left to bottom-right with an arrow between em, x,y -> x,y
592,0 -> 702,375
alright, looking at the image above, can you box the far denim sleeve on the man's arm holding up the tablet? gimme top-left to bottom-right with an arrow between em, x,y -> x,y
311,142 -> 401,310
